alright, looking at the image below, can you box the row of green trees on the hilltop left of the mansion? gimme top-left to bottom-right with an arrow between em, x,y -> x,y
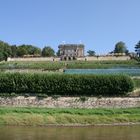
0,41 -> 55,61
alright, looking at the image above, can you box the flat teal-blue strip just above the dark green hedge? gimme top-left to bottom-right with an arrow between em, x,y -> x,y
64,68 -> 140,76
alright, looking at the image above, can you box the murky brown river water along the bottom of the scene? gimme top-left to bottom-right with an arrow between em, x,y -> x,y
0,126 -> 140,140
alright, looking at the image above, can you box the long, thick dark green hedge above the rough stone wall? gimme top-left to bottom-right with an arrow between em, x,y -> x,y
0,73 -> 134,96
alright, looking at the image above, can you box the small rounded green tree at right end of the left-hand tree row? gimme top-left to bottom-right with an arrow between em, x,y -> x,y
42,46 -> 55,57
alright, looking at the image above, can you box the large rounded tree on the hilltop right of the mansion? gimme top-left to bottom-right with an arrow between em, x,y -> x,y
114,41 -> 128,54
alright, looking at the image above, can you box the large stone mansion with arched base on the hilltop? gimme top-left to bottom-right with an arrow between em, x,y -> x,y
58,44 -> 84,60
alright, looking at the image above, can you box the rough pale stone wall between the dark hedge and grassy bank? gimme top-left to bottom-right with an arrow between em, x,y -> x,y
0,96 -> 140,108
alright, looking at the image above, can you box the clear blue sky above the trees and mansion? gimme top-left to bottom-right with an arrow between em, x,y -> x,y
0,0 -> 140,54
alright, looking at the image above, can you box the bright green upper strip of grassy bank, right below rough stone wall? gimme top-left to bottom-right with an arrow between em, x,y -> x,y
0,107 -> 140,118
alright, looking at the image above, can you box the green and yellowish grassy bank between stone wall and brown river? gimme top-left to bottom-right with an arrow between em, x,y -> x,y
0,107 -> 140,126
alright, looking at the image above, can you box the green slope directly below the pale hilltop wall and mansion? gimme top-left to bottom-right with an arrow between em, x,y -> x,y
0,60 -> 140,70
